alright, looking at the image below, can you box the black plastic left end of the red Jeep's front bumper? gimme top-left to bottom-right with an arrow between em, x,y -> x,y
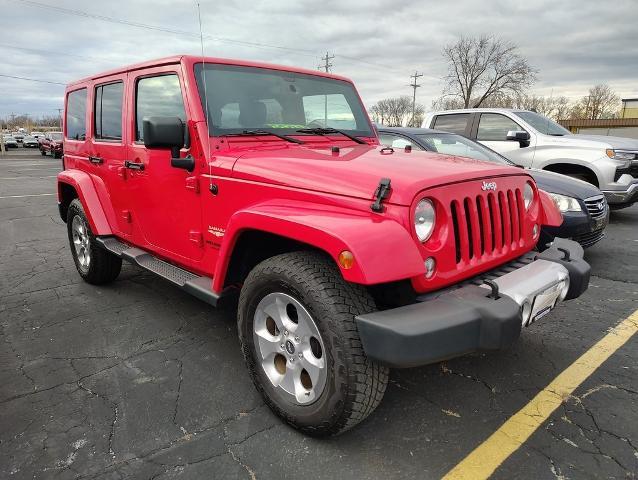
356,285 -> 522,368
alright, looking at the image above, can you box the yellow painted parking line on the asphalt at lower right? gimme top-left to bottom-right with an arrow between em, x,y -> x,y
443,310 -> 638,480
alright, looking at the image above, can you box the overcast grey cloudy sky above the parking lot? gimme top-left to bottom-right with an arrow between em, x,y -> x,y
0,0 -> 638,117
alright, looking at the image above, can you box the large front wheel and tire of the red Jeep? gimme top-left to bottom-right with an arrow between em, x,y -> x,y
238,252 -> 388,435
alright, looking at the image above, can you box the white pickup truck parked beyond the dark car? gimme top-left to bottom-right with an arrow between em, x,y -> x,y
422,108 -> 638,208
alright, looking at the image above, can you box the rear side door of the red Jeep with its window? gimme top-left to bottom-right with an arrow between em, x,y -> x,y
88,73 -> 132,238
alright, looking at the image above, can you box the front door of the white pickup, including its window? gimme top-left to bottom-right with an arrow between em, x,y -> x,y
476,113 -> 535,167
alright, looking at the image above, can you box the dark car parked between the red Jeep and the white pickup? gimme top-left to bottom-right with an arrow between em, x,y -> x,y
378,127 -> 609,249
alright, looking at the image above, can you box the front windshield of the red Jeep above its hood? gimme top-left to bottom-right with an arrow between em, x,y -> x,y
195,63 -> 374,137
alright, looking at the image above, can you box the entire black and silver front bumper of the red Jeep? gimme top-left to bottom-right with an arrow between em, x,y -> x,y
356,239 -> 590,367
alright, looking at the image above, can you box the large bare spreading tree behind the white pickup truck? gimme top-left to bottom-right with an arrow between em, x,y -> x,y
443,35 -> 536,108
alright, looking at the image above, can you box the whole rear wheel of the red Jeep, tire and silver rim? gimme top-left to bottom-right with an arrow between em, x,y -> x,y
66,199 -> 122,285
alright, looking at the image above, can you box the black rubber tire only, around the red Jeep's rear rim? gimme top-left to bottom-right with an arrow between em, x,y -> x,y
66,198 -> 122,285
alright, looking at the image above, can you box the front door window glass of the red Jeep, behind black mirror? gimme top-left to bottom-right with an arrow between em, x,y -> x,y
135,74 -> 186,140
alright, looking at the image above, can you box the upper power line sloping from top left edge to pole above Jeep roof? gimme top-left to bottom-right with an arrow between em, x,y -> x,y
15,0 -> 316,57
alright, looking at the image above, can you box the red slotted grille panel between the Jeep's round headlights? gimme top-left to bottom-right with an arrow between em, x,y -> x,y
450,188 -> 525,264
